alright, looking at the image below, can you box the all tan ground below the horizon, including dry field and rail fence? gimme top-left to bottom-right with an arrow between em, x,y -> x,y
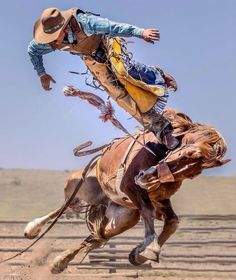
0,170 -> 236,280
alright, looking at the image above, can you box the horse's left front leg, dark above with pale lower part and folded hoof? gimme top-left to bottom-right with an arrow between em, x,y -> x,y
123,185 -> 160,265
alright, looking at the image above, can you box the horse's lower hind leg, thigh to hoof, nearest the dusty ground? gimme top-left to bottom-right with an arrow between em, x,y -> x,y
51,203 -> 140,273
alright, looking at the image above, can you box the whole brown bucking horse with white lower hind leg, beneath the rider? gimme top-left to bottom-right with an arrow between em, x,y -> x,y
25,109 -> 228,273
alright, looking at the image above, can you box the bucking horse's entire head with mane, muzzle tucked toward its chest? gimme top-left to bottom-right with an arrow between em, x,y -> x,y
136,109 -> 229,188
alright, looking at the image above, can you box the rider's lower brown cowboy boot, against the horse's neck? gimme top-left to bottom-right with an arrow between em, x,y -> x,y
150,114 -> 179,150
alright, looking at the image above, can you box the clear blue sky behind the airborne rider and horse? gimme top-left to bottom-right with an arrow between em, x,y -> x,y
0,0 -> 236,175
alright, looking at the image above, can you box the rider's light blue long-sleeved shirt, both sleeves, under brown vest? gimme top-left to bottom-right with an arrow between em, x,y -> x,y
28,13 -> 144,76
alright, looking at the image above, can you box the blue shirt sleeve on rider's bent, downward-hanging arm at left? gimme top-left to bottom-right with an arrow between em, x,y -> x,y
28,40 -> 54,76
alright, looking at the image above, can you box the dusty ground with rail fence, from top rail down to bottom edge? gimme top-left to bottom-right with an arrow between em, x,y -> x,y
0,216 -> 236,280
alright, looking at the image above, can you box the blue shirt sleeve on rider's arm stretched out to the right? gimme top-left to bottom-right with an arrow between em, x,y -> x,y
77,13 -> 144,38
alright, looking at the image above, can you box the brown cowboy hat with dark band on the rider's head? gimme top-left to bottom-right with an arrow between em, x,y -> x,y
34,8 -> 73,43
